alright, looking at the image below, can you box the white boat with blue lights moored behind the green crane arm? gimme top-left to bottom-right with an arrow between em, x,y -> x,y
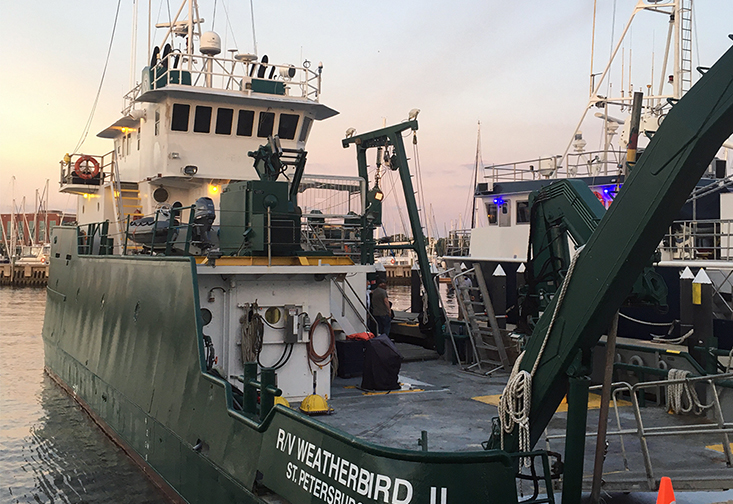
449,0 -> 733,345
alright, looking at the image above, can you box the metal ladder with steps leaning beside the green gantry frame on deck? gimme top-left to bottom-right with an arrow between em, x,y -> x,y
448,263 -> 512,374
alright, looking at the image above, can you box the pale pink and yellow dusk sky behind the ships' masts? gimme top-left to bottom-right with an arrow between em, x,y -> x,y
0,0 -> 733,234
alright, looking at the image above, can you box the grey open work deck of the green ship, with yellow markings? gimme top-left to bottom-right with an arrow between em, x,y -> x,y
319,344 -> 733,491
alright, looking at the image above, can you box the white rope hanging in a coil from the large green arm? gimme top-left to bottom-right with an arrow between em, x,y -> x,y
498,245 -> 585,456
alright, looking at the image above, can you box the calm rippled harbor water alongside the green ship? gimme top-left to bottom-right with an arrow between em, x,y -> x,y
0,287 -> 733,504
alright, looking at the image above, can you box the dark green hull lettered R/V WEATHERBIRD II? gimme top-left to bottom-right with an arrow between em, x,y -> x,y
43,228 -> 517,504
